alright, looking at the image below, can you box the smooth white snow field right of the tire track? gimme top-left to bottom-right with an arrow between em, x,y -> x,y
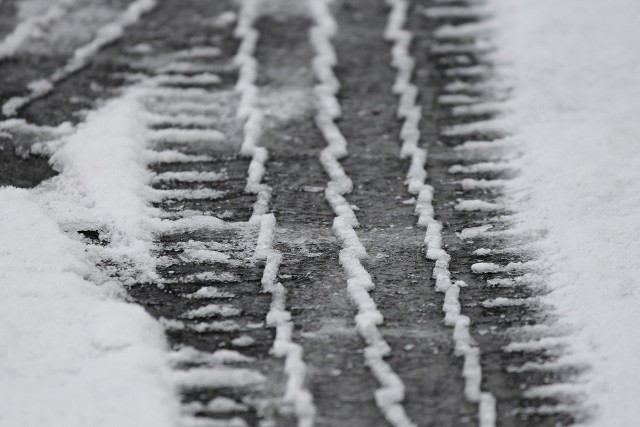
490,0 -> 640,427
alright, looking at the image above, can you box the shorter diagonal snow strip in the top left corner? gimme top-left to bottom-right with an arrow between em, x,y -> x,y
0,0 -> 77,60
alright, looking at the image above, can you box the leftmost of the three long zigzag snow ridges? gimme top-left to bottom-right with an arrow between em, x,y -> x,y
235,0 -> 316,427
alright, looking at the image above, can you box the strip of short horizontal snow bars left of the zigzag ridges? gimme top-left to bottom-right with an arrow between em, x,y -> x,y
130,56 -> 283,426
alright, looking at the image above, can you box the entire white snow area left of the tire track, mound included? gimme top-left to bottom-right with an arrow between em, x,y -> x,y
0,93 -> 178,427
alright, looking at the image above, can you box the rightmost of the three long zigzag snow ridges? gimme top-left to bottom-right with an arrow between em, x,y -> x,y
384,0 -> 496,427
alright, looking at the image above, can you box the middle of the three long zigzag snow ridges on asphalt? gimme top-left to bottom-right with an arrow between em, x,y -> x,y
309,0 -> 416,427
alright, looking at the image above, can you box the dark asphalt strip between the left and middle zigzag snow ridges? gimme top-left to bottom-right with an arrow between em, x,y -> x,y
252,8 -> 385,427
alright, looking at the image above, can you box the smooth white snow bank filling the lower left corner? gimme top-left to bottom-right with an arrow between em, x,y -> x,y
0,188 -> 177,427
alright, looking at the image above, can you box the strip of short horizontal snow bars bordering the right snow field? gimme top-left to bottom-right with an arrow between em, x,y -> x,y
411,2 -> 582,426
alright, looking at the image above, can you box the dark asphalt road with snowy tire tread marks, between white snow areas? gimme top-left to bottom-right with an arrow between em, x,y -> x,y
0,0 -> 580,427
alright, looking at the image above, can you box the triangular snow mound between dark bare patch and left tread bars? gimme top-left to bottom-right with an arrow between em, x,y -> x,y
40,91 -> 156,282
